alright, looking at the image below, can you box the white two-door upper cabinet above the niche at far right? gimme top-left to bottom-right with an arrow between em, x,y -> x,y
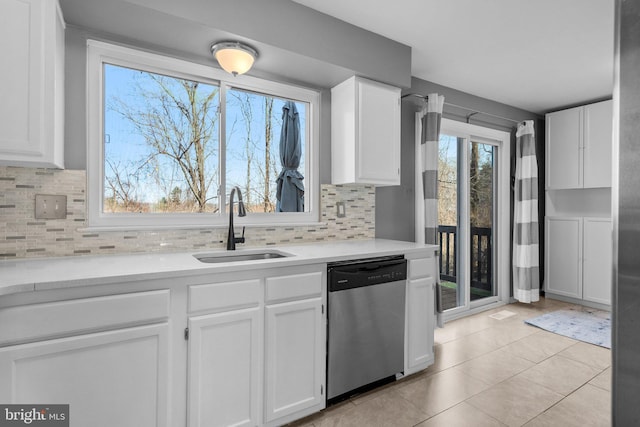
546,101 -> 613,190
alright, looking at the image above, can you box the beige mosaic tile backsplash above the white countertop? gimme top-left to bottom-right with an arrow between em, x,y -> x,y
0,166 -> 375,259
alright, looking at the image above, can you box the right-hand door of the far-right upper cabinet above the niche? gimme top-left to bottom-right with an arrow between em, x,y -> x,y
584,101 -> 613,188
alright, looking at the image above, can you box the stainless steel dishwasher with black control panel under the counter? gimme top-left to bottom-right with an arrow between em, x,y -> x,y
327,256 -> 407,404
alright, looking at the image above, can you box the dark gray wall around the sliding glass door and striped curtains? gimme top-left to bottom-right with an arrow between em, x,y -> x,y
376,77 -> 544,244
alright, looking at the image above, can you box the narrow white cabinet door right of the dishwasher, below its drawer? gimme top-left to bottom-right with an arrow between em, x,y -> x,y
405,277 -> 435,375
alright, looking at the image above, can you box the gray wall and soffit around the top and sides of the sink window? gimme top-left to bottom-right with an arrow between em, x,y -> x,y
60,0 -> 411,184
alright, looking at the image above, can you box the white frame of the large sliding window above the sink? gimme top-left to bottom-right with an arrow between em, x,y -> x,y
87,40 -> 320,230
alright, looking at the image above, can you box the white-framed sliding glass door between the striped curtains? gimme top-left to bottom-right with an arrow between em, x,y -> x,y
438,120 -> 510,318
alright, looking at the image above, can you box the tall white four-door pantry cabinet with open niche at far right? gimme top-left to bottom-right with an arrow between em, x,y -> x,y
544,101 -> 612,308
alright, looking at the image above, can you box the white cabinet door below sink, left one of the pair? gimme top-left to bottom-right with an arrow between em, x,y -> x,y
188,307 -> 262,427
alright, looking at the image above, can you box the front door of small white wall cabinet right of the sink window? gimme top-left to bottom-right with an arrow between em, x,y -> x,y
356,80 -> 400,185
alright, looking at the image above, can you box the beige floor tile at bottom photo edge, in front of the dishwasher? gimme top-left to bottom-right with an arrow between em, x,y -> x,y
313,390 -> 429,427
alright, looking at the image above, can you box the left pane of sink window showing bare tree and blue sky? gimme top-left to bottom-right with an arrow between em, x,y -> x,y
104,65 -> 219,213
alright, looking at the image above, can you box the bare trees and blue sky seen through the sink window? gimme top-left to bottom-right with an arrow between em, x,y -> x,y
103,64 -> 307,217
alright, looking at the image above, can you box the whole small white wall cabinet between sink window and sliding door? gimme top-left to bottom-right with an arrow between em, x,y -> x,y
331,77 -> 400,185
